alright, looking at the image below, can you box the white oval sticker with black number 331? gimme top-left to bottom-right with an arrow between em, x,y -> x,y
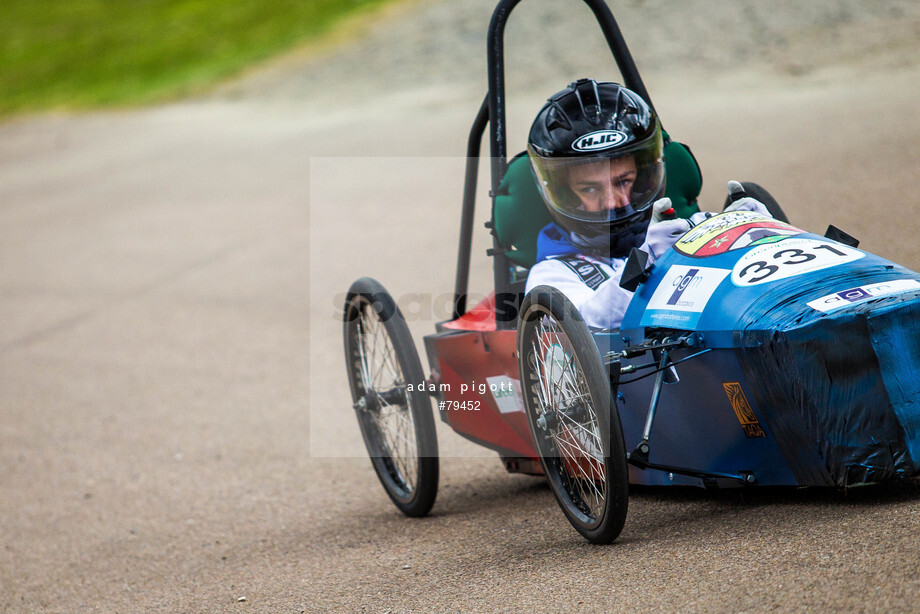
732,238 -> 866,286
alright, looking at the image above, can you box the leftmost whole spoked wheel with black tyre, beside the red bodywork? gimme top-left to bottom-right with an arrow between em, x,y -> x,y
345,277 -> 438,516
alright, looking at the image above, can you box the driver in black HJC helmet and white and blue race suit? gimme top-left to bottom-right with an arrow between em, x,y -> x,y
526,79 -> 769,328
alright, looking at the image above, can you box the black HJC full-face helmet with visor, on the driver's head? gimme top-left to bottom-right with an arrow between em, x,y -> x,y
527,79 -> 664,256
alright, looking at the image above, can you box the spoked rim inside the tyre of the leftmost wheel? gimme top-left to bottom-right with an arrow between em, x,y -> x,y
355,300 -> 419,499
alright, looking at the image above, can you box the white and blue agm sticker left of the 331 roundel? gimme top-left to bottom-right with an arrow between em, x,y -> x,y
640,264 -> 729,327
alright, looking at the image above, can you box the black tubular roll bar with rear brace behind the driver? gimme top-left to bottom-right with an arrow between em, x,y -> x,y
453,0 -> 655,328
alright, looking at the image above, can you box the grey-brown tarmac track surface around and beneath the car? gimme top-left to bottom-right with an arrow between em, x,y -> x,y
0,0 -> 920,613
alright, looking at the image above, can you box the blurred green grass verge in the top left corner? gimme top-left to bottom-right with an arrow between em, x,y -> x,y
0,0 -> 387,116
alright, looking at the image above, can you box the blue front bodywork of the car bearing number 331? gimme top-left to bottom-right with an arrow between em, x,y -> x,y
595,212 -> 920,487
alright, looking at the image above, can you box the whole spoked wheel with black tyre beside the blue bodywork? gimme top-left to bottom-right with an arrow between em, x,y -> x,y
518,286 -> 629,544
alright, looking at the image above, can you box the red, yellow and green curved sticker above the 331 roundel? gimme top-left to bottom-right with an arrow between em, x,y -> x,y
674,211 -> 804,258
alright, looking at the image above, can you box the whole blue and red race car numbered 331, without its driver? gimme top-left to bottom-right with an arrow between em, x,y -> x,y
344,0 -> 920,543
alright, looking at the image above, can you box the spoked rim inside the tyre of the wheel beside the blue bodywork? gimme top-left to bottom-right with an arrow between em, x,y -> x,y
530,309 -> 608,526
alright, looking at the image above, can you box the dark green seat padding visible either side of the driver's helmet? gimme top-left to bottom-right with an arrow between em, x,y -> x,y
492,134 -> 703,268
